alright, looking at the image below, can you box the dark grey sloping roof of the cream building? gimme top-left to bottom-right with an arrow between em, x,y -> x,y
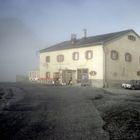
40,29 -> 138,53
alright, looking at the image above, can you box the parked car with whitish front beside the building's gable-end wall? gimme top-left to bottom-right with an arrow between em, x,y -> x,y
122,80 -> 140,89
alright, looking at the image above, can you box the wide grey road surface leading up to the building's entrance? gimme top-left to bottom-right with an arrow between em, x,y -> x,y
0,83 -> 108,140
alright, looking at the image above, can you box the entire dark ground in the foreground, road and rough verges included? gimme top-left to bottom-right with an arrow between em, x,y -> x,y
0,83 -> 140,140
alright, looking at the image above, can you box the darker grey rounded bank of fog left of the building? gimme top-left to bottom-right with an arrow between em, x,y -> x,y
0,18 -> 40,82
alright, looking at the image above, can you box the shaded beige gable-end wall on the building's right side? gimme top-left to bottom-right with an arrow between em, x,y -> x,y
105,32 -> 140,80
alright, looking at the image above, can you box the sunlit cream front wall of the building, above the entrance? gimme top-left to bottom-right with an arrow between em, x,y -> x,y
40,45 -> 103,80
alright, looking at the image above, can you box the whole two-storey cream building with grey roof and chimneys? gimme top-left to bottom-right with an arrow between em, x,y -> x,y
40,30 -> 140,87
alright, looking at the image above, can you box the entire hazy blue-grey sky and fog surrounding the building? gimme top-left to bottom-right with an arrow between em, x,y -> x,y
0,0 -> 140,81
